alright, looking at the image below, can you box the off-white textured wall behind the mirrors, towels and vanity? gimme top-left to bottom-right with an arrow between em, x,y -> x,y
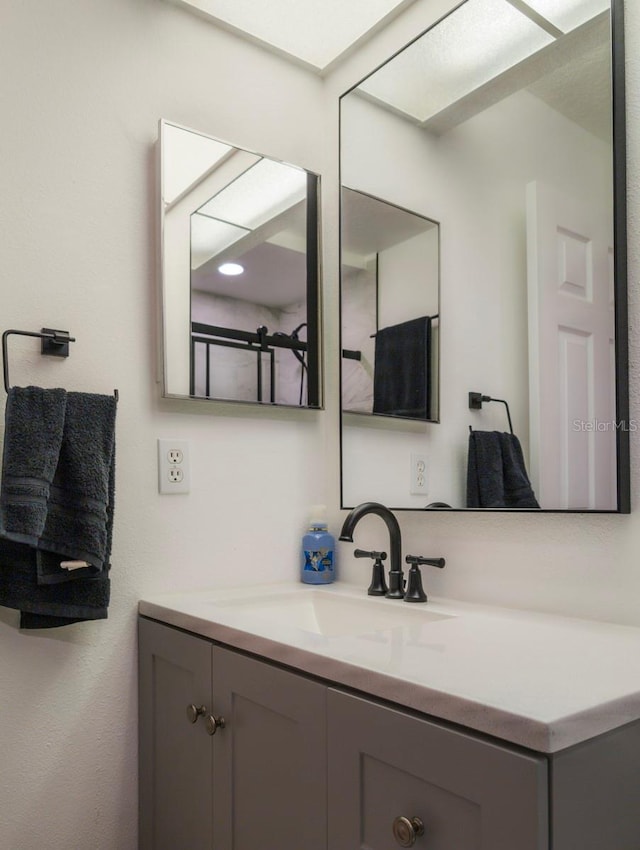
0,0 -> 640,850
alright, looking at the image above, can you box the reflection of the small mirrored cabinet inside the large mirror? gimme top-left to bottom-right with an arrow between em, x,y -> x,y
341,187 -> 439,420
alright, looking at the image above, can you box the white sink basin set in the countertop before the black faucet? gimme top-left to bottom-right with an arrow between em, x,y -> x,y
214,588 -> 450,637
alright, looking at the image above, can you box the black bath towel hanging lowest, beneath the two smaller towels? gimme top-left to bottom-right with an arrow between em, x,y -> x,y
0,538 -> 110,629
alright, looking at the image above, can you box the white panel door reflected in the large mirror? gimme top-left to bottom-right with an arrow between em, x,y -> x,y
527,182 -> 617,510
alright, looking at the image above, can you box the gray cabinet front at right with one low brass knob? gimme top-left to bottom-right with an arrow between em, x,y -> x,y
328,690 -> 548,850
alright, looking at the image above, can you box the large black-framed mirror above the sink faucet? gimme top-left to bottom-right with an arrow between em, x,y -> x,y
340,0 -> 635,513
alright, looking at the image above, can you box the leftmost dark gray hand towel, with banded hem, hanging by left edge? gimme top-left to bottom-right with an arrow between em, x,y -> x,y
0,387 -> 67,546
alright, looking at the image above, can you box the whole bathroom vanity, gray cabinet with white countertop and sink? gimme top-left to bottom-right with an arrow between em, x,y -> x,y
139,583 -> 640,850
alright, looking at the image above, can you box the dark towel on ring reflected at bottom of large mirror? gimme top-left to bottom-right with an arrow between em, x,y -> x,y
467,431 -> 540,508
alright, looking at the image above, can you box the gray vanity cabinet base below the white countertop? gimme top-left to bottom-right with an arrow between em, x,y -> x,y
139,617 -> 640,850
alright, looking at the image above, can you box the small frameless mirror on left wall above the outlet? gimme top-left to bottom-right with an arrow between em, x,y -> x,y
159,120 -> 322,408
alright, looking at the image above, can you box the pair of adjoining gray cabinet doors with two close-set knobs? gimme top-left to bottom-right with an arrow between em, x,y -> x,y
139,618 -> 327,850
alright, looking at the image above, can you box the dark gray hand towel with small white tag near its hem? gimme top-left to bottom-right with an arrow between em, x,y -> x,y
38,392 -> 116,584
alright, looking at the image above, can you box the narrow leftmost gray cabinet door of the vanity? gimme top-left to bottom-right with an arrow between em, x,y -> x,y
139,619 -> 213,850
